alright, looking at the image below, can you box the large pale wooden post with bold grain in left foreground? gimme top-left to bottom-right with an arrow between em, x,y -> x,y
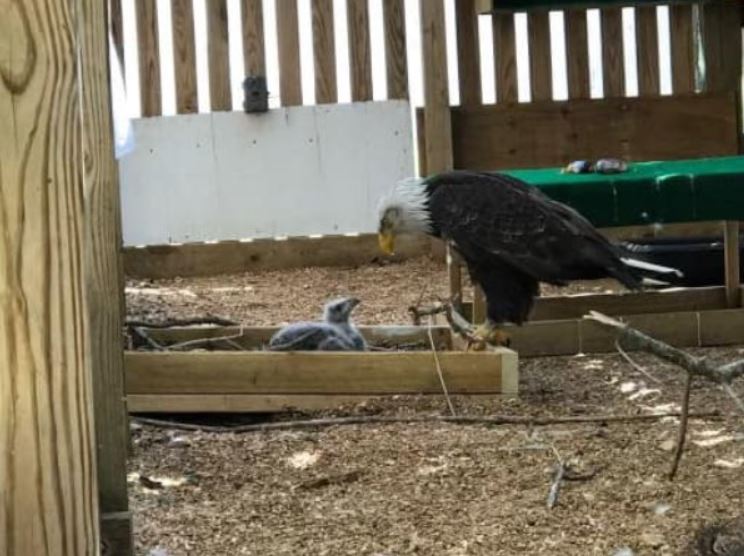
0,0 -> 99,556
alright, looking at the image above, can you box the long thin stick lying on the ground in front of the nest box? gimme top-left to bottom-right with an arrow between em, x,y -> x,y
132,411 -> 732,433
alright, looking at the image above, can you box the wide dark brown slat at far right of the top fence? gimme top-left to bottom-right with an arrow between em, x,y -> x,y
702,0 -> 742,92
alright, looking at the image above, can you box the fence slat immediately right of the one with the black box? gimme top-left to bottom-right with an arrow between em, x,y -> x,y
276,0 -> 302,106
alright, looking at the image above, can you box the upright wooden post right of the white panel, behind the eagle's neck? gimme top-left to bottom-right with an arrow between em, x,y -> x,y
421,0 -> 462,299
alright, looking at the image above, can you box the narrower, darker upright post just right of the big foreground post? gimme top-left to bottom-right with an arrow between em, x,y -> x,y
80,0 -> 133,556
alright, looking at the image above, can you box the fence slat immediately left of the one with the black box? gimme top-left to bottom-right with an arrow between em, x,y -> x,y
205,0 -> 232,111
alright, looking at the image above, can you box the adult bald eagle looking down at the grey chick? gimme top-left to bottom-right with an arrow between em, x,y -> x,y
378,171 -> 681,344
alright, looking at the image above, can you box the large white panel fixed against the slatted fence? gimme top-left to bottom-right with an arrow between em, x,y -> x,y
120,101 -> 414,245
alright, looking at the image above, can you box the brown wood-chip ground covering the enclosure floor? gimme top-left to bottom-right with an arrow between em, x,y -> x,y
127,259 -> 744,556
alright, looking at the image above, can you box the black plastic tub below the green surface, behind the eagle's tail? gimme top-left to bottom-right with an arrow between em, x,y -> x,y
622,236 -> 744,287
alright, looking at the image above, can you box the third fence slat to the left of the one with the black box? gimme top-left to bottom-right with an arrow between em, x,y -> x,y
135,0 -> 163,117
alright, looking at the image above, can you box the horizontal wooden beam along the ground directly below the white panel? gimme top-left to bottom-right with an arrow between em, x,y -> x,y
124,234 -> 431,278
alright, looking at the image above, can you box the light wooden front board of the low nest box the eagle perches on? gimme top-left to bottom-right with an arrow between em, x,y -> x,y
125,349 -> 518,395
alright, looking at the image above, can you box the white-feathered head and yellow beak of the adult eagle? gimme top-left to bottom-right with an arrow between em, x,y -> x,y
377,178 -> 431,255
